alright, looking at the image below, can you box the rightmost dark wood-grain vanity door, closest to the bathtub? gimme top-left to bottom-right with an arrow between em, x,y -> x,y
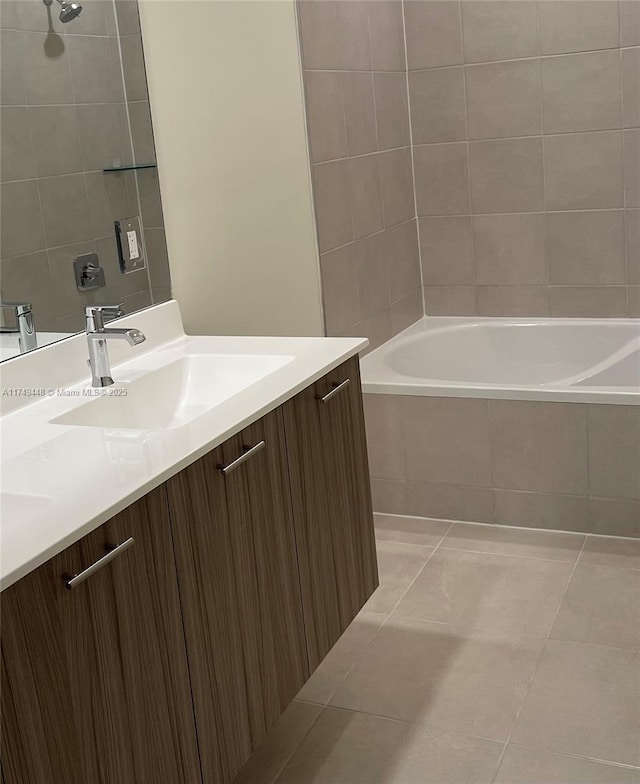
284,357 -> 378,669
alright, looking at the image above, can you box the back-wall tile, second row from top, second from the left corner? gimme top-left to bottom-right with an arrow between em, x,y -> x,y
466,60 -> 542,139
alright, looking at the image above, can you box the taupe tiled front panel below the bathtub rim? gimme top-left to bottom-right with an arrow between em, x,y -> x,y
365,394 -> 640,537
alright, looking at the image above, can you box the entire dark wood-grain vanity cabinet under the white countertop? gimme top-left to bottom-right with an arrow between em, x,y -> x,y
1,358 -> 377,784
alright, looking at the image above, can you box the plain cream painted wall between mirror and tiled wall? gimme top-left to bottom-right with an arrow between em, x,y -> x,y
140,0 -> 323,335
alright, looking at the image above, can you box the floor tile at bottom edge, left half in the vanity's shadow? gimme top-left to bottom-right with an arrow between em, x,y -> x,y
277,708 -> 502,784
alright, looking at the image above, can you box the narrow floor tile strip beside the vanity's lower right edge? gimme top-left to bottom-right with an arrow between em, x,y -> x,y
298,611 -> 387,705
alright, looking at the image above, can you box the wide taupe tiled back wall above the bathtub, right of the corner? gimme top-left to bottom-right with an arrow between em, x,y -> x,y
404,0 -> 640,317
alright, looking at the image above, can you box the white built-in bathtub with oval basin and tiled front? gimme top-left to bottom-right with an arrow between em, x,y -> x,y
362,316 -> 640,405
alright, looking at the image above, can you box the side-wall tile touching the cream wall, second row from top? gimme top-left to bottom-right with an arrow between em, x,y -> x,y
305,71 -> 347,163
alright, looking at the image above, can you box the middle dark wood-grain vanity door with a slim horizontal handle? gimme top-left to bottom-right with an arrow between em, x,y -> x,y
167,412 -> 308,784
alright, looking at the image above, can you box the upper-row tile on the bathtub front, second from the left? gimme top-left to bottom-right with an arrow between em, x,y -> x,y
401,397 -> 491,487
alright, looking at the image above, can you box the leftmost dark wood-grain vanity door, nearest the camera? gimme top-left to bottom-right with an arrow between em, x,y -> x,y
2,488 -> 201,784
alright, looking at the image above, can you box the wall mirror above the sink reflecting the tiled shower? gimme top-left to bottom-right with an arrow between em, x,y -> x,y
0,0 -> 170,359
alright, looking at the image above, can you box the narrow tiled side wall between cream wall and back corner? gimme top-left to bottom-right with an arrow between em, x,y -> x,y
298,0 -> 423,345
